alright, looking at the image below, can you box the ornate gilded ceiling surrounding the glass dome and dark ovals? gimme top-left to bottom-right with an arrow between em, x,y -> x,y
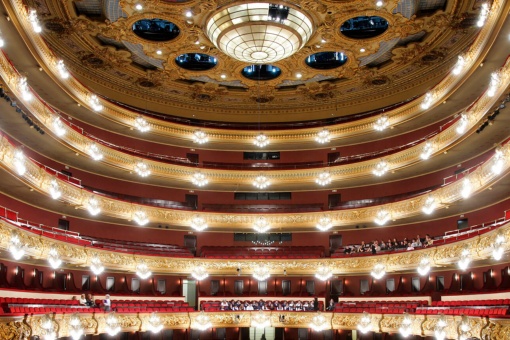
31,0 -> 481,123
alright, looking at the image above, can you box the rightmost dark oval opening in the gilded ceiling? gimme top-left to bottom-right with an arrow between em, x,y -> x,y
340,16 -> 388,39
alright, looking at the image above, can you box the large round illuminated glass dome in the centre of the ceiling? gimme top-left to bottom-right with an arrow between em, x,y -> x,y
205,2 -> 314,64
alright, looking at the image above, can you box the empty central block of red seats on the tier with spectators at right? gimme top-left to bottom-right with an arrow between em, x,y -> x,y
200,246 -> 325,259
